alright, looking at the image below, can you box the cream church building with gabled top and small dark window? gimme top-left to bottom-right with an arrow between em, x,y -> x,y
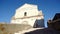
11,3 -> 44,27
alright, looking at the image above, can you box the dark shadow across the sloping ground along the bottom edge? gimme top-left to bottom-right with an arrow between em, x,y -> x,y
25,28 -> 60,34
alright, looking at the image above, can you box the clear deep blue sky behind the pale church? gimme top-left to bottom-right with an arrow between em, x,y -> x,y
0,0 -> 60,26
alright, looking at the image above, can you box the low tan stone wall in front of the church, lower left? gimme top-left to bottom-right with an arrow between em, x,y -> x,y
0,24 -> 32,34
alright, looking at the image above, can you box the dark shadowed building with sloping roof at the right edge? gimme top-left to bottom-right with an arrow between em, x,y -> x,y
47,13 -> 60,31
